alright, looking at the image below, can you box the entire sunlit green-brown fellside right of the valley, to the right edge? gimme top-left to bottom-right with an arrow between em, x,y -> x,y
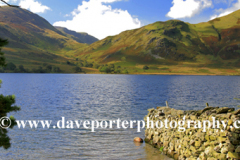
75,11 -> 240,65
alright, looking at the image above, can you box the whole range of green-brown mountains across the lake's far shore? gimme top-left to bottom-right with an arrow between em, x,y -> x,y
0,7 -> 240,74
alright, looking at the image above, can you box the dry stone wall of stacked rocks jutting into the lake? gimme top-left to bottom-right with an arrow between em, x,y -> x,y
144,107 -> 240,160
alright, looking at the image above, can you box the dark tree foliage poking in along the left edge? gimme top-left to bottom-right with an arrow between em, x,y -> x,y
0,39 -> 20,149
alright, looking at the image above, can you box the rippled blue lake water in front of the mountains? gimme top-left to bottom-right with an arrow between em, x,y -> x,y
0,74 -> 240,160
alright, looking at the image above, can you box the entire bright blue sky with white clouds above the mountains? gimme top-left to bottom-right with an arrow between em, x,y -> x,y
0,0 -> 240,39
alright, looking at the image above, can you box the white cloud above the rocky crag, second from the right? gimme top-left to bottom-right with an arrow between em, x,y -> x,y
166,0 -> 212,19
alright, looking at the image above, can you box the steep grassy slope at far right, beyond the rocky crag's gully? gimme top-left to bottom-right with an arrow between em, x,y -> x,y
195,10 -> 240,60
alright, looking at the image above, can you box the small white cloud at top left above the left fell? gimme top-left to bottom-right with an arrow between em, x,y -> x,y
19,0 -> 51,13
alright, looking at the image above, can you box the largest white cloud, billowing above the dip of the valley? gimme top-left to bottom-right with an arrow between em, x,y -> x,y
53,0 -> 141,39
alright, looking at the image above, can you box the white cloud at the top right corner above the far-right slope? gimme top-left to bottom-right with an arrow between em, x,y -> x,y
210,0 -> 240,20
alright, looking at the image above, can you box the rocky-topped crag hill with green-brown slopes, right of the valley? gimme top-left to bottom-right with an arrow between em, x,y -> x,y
75,20 -> 206,62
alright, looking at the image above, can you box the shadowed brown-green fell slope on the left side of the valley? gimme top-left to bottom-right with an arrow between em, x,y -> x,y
0,6 -> 87,72
